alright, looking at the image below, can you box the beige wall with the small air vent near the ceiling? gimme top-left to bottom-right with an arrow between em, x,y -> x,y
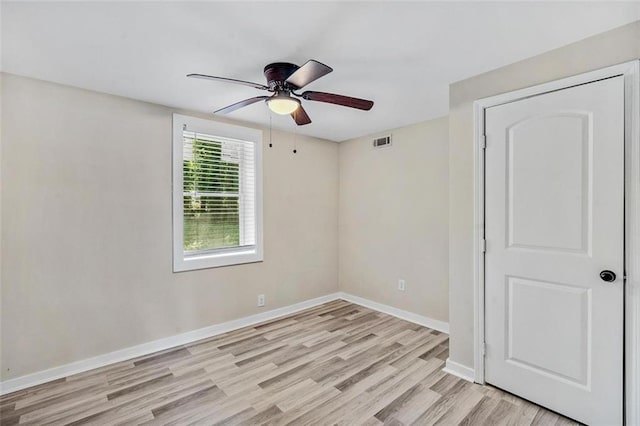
339,117 -> 449,322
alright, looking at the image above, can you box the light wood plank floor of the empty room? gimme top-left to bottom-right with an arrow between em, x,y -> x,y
0,301 -> 575,425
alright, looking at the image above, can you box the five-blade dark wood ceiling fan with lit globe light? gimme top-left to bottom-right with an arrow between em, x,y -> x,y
187,59 -> 373,126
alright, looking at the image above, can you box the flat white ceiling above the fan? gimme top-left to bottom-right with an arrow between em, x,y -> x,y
2,1 -> 640,141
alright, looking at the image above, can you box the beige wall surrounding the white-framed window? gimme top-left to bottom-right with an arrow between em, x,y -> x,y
0,74 -> 338,380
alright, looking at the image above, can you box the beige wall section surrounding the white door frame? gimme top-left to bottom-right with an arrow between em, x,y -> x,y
449,21 -> 640,367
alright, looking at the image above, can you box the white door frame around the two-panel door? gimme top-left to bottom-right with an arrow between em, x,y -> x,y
473,60 -> 640,425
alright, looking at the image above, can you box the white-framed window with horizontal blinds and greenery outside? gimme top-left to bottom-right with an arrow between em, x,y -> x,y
173,114 -> 262,272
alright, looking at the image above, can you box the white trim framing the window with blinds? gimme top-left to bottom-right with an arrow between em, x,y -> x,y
172,114 -> 264,272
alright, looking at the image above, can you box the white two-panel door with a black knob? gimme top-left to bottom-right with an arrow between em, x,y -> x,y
485,77 -> 624,425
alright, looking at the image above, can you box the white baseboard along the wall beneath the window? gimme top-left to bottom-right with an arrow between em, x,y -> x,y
0,293 -> 340,395
